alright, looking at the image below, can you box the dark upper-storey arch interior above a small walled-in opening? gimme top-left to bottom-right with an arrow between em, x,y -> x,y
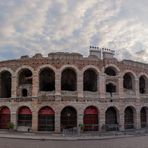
19,69 -> 32,85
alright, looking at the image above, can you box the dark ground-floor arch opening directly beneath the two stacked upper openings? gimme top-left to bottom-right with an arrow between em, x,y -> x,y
105,107 -> 118,131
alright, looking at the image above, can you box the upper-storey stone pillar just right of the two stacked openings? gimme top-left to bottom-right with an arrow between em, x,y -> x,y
118,76 -> 124,98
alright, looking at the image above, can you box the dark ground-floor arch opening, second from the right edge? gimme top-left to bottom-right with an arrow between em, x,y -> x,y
124,107 -> 134,129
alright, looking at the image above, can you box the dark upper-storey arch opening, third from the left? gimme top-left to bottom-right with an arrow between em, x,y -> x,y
39,68 -> 55,91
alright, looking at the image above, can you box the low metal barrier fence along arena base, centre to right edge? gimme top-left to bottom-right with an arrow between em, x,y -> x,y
62,124 -> 148,136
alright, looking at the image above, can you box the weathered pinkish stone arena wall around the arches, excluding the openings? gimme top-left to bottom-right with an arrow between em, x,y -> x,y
0,53 -> 148,132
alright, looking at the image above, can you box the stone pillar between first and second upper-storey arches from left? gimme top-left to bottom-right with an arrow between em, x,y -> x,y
11,75 -> 17,98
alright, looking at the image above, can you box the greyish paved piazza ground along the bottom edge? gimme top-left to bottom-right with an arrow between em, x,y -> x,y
0,136 -> 148,148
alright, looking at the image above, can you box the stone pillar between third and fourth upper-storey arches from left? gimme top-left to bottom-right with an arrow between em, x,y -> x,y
55,70 -> 61,100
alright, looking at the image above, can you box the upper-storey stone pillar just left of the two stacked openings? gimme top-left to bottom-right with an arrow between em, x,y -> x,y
98,73 -> 106,99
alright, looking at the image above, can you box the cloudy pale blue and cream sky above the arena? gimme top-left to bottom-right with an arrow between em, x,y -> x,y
0,0 -> 148,63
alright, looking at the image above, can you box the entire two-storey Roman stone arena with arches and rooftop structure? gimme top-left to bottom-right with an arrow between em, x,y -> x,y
0,47 -> 148,133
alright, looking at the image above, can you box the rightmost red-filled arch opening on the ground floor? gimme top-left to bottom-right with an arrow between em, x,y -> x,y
83,106 -> 99,131
